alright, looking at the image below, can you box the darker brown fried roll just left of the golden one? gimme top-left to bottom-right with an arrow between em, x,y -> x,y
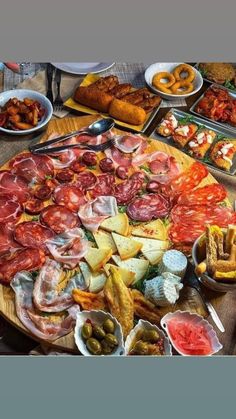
74,86 -> 113,113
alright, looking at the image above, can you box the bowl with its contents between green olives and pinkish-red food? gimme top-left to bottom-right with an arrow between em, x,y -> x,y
125,320 -> 172,356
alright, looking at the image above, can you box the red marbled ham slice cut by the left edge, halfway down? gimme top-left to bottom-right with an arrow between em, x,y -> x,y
0,194 -> 23,224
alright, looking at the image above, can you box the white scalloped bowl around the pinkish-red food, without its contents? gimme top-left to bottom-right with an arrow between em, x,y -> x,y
161,310 -> 223,356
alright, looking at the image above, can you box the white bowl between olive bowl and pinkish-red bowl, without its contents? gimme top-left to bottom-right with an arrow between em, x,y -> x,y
125,320 -> 172,356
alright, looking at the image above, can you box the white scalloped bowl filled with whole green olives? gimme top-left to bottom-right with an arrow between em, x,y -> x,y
74,310 -> 125,356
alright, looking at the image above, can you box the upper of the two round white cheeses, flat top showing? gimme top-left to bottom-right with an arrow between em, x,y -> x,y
159,250 -> 188,279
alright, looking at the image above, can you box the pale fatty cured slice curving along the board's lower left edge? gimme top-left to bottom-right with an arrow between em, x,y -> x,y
11,272 -> 80,341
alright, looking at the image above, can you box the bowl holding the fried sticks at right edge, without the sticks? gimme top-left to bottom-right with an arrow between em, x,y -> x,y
192,235 -> 236,292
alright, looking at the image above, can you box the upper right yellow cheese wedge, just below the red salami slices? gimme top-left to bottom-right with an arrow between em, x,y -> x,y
132,220 -> 167,240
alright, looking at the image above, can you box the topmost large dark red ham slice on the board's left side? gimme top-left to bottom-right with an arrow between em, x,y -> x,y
10,153 -> 54,182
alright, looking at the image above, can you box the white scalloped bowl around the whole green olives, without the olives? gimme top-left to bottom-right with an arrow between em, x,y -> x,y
74,310 -> 125,356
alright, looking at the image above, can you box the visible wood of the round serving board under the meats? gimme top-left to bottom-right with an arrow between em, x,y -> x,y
0,115 -> 225,353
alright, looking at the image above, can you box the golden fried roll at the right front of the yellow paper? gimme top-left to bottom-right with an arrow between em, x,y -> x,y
109,99 -> 146,125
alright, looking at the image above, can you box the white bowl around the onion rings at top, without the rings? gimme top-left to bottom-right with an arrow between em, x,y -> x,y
144,63 -> 203,100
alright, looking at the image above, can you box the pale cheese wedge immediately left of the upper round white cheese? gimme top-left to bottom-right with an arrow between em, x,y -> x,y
133,237 -> 169,265
